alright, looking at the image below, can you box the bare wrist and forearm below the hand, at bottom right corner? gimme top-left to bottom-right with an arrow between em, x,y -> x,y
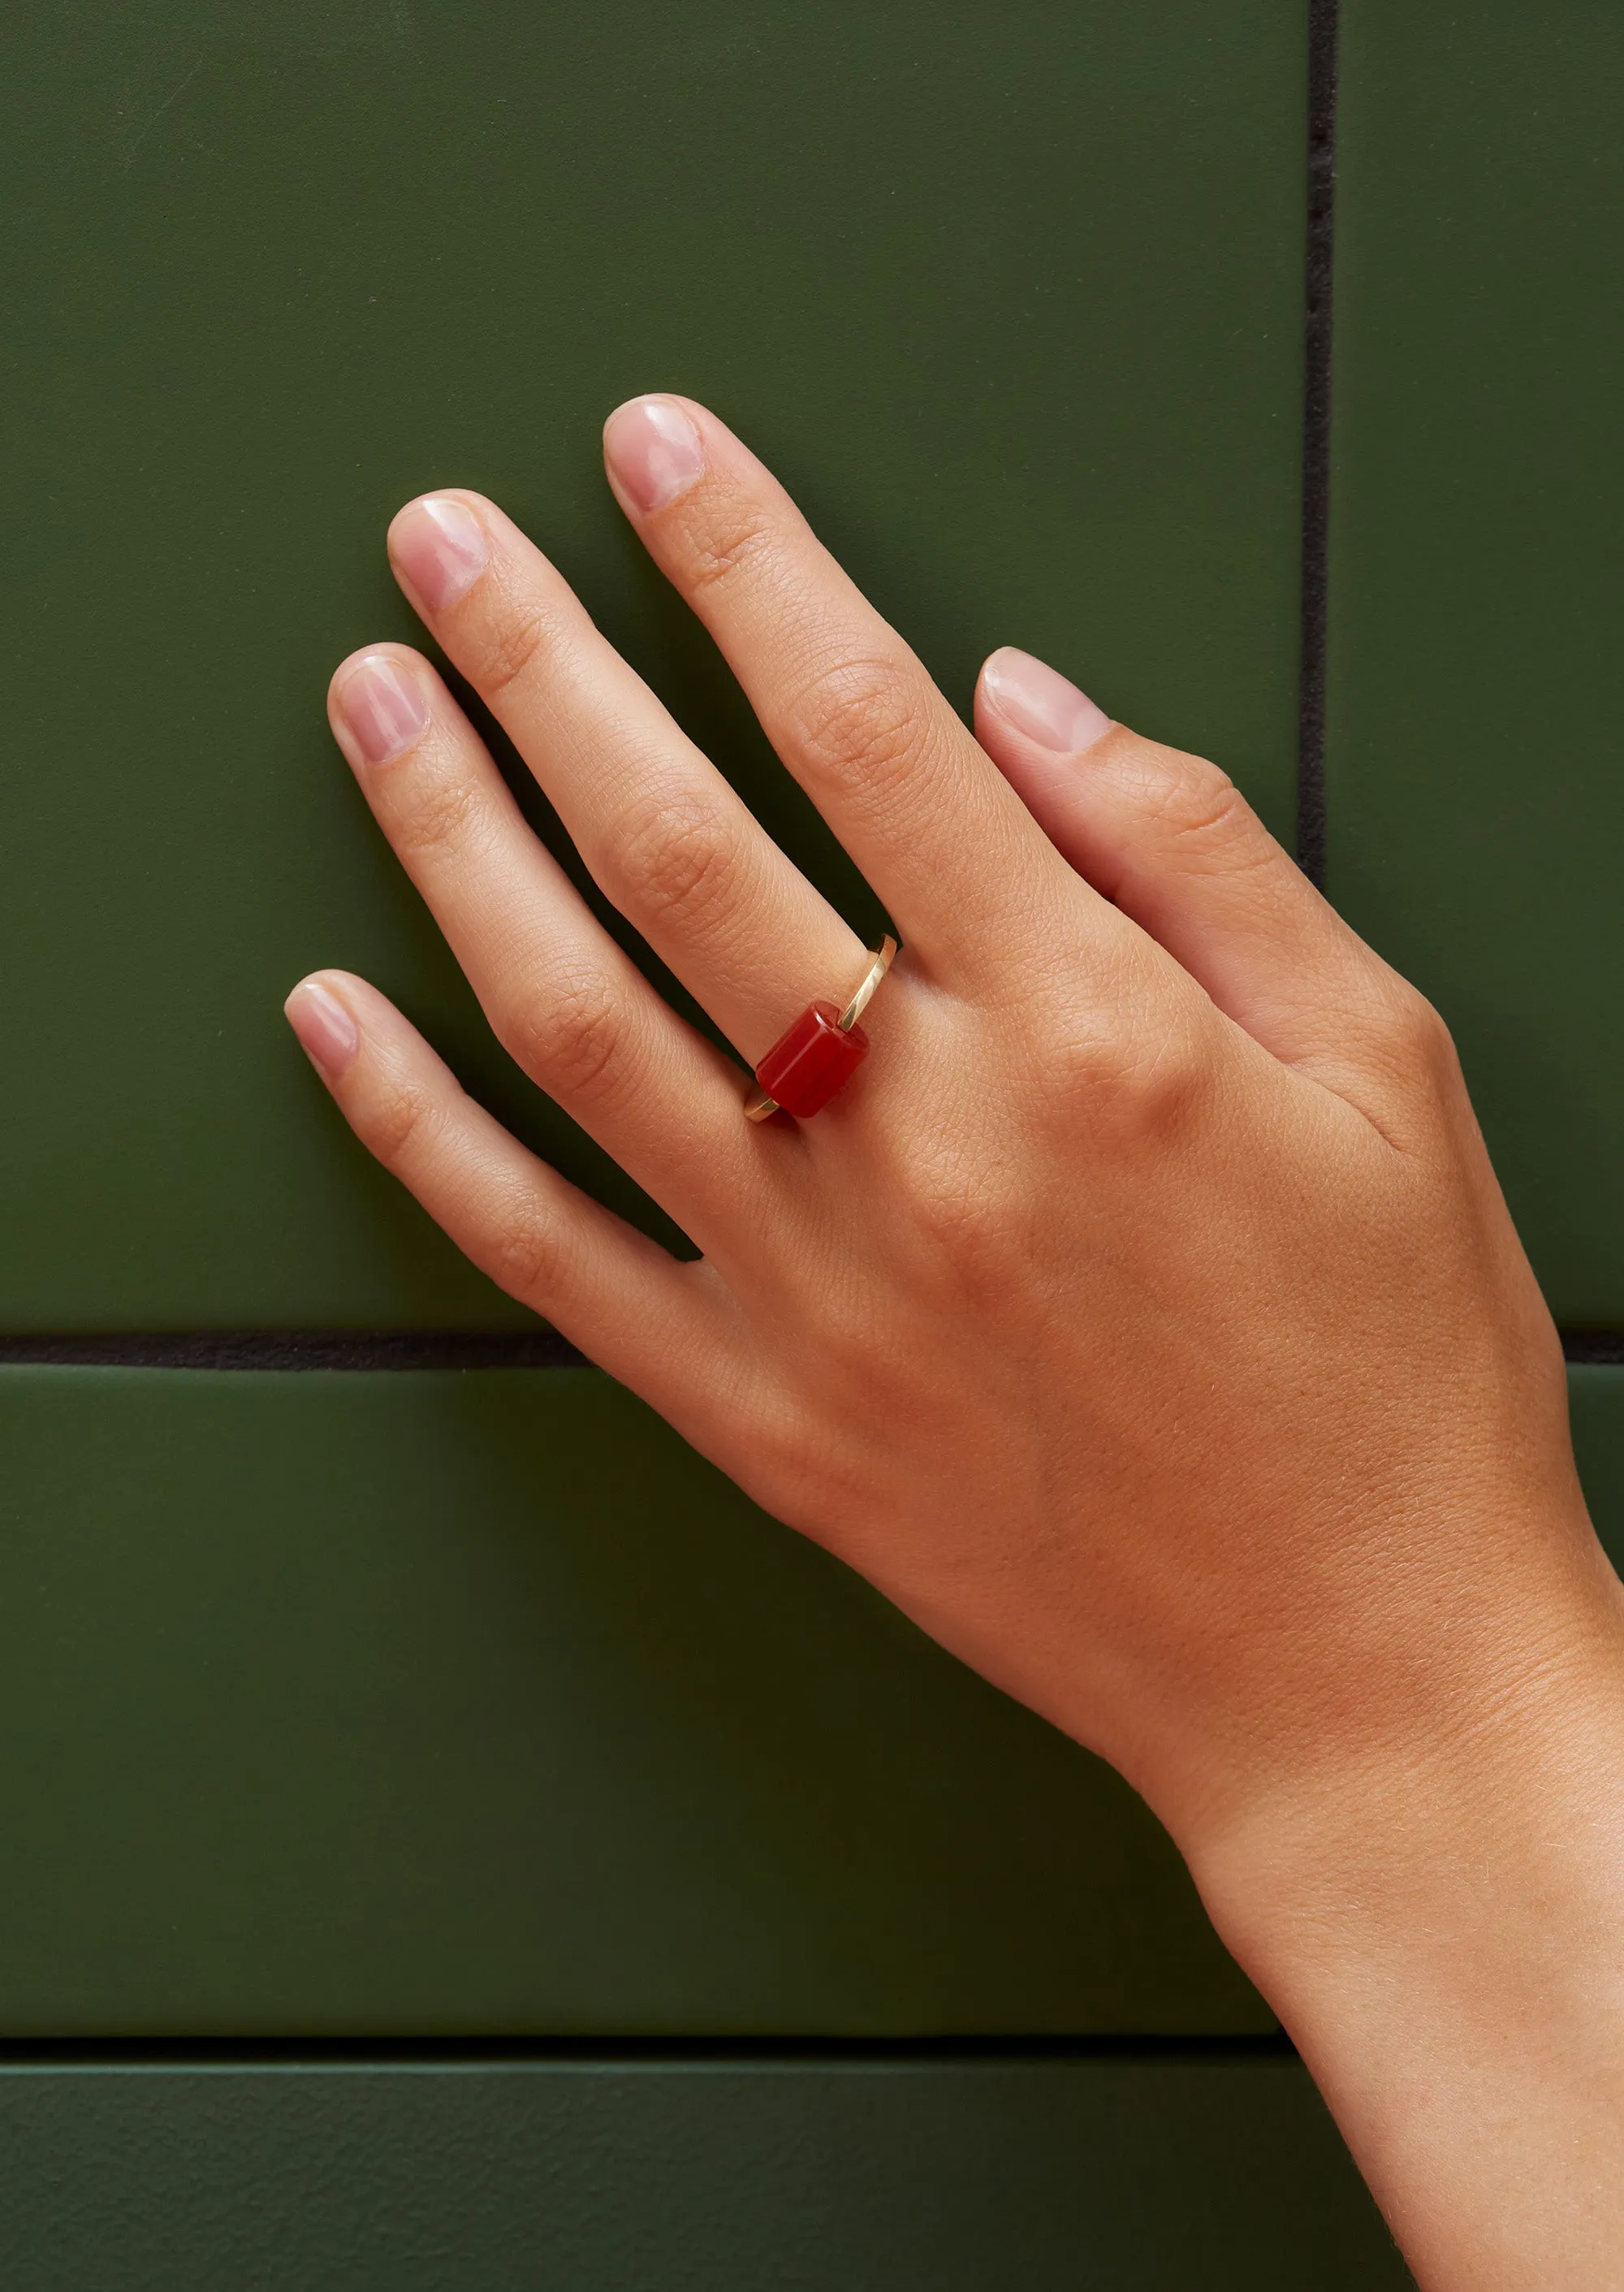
1209,1595 -> 1624,2292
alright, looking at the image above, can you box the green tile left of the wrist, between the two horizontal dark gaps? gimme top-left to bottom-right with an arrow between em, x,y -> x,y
0,1369 -> 1272,2038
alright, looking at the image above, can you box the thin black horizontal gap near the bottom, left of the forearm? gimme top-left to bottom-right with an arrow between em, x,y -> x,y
0,2030 -> 1297,2074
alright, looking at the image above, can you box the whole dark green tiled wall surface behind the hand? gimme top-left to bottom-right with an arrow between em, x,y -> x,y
0,0 -> 1624,2264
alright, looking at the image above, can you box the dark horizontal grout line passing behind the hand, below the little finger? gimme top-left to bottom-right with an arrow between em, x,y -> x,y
0,1330 -> 1624,1371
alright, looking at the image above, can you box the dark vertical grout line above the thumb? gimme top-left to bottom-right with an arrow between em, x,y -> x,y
1297,0 -> 1337,884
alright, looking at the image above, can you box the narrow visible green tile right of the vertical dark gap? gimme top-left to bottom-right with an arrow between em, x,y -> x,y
1328,0 -> 1624,1325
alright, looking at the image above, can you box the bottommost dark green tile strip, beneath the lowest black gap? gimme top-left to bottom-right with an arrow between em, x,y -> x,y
0,2061 -> 1411,2292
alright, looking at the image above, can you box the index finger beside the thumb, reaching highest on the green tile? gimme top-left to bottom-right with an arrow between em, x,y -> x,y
605,396 -> 1074,962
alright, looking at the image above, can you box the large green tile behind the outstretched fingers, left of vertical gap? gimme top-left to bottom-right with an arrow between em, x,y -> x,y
0,0 -> 1303,1330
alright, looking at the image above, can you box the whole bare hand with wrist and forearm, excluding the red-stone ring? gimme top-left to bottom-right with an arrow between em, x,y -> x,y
288,399 -> 1624,2292
